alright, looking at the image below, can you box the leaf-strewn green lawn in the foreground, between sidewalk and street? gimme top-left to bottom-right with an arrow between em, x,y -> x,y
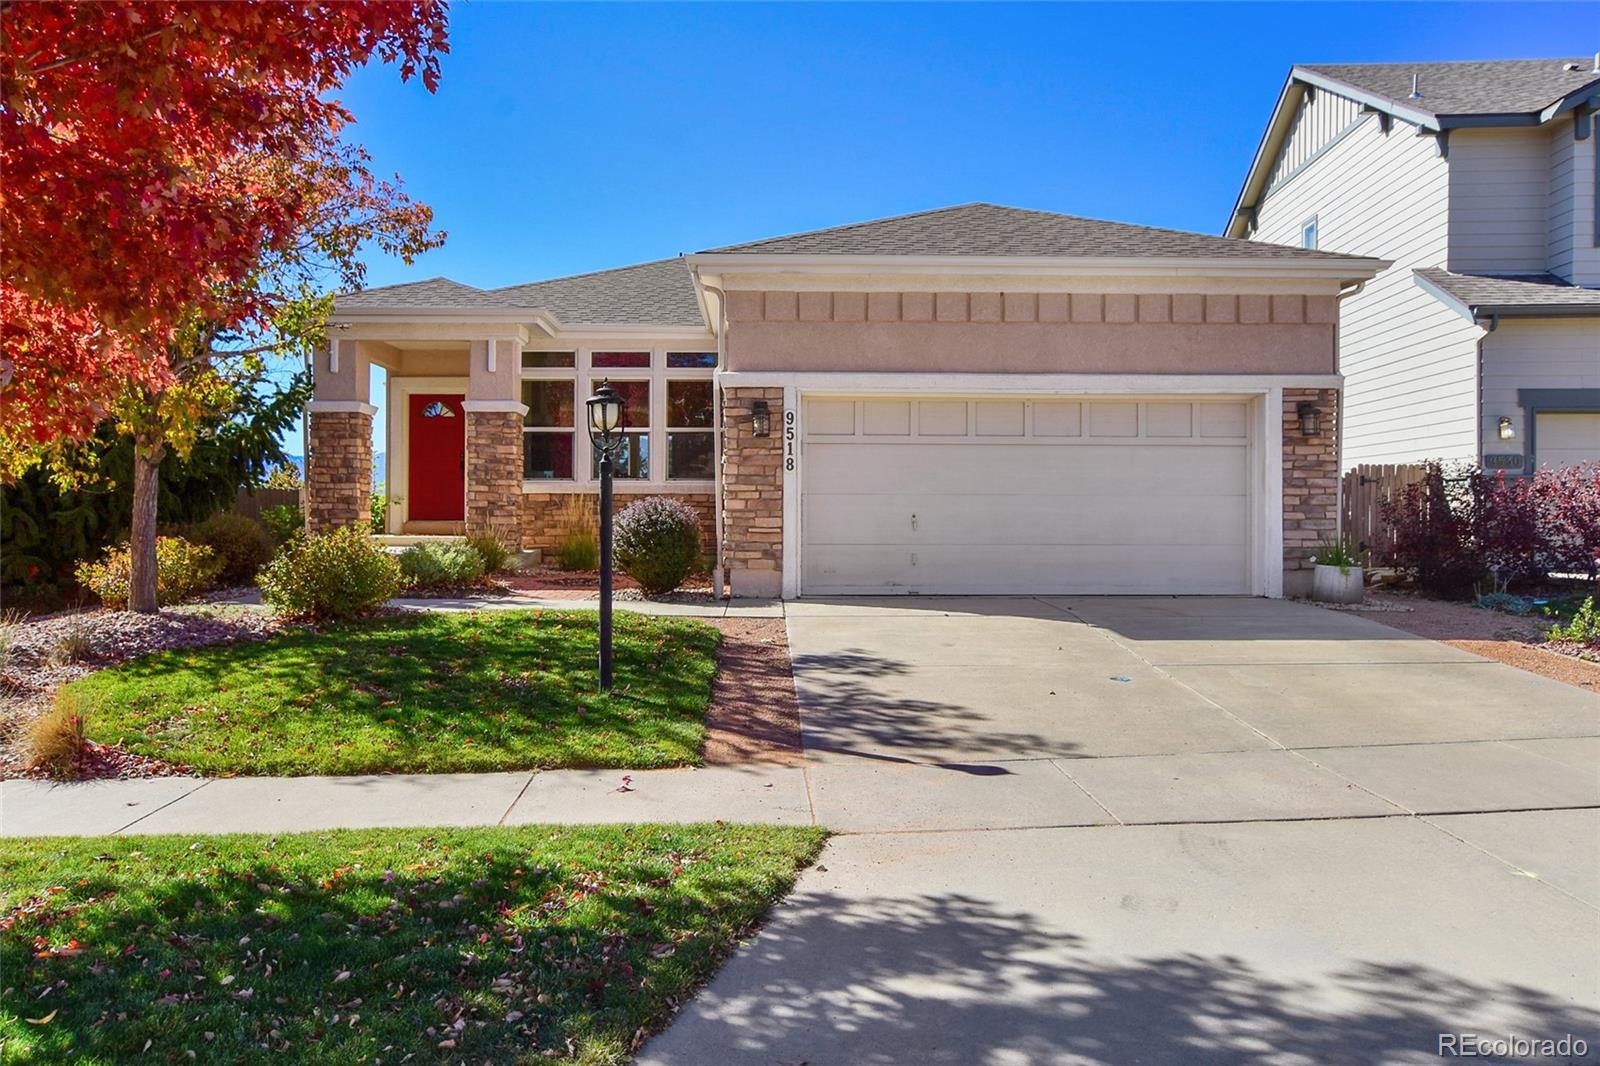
0,824 -> 822,1066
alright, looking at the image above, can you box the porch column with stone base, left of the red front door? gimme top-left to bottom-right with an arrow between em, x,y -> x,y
306,339 -> 378,533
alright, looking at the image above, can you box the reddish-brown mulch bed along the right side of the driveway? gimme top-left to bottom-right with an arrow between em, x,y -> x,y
1366,589 -> 1600,693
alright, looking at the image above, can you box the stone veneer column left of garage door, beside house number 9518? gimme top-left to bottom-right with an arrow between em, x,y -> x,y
722,389 -> 784,597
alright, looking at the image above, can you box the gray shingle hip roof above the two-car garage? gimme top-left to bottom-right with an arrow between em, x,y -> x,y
707,203 -> 1358,259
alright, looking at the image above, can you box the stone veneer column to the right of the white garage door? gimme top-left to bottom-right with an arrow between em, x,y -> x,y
1283,389 -> 1339,595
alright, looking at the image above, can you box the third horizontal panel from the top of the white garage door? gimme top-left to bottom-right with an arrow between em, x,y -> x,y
802,493 -> 1248,546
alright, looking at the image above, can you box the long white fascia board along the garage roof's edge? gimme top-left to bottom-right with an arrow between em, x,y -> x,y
688,253 -> 1390,281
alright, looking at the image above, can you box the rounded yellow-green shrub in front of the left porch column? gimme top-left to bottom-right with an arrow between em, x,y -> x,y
259,525 -> 400,621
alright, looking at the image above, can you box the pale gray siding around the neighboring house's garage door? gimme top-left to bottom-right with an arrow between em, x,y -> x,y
1482,319 -> 1600,455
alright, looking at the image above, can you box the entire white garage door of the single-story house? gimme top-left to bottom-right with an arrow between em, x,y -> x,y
800,399 -> 1251,595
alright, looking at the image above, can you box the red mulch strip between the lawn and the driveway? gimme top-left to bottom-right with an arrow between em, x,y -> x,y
702,618 -> 805,767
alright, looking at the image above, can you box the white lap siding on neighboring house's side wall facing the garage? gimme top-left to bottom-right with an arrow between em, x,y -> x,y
1251,108 -> 1482,469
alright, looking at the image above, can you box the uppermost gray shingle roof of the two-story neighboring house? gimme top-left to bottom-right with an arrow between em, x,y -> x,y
1296,56 -> 1600,115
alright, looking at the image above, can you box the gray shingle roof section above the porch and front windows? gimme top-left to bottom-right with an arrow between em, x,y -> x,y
338,259 -> 706,327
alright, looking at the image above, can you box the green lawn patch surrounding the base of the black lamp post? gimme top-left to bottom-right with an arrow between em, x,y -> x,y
69,610 -> 718,775
